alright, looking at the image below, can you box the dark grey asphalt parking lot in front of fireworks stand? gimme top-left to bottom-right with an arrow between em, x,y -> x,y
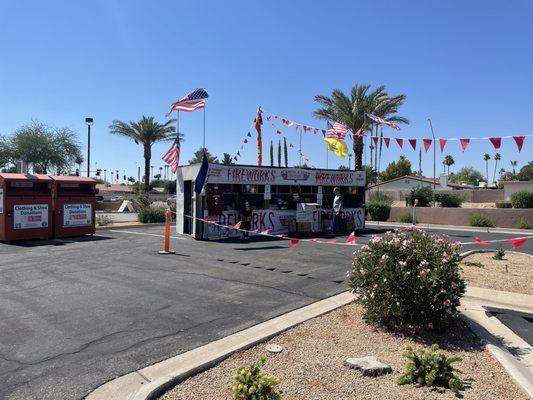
0,226 -> 533,400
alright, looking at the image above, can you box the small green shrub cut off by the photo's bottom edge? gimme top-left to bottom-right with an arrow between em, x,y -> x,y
231,357 -> 281,400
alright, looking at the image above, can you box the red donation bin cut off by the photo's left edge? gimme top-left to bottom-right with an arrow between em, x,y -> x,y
0,174 -> 52,242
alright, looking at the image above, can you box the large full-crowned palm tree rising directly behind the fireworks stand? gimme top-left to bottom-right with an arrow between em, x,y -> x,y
314,85 -> 409,171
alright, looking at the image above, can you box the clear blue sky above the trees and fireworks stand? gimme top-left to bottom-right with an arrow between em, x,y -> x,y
0,0 -> 533,181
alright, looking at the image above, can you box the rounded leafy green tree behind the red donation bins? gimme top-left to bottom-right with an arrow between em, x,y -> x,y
8,121 -> 81,174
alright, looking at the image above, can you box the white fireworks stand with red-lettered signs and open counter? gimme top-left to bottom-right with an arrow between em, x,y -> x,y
176,164 -> 365,239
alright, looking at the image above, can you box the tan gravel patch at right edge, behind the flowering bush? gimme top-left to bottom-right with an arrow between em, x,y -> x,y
460,252 -> 533,295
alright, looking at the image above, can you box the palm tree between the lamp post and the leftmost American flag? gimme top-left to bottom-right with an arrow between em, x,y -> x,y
109,115 -> 176,192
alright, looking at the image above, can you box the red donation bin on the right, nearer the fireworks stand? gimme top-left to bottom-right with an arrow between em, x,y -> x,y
50,175 -> 96,238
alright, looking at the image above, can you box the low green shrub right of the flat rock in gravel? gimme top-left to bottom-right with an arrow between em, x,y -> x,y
396,344 -> 463,392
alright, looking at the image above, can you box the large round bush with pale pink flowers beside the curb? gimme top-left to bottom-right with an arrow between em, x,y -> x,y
349,228 -> 465,330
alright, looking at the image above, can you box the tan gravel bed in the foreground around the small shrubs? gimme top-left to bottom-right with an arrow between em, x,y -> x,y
161,304 -> 527,400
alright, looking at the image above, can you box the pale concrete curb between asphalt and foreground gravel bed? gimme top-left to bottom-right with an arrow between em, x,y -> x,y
86,292 -> 355,400
